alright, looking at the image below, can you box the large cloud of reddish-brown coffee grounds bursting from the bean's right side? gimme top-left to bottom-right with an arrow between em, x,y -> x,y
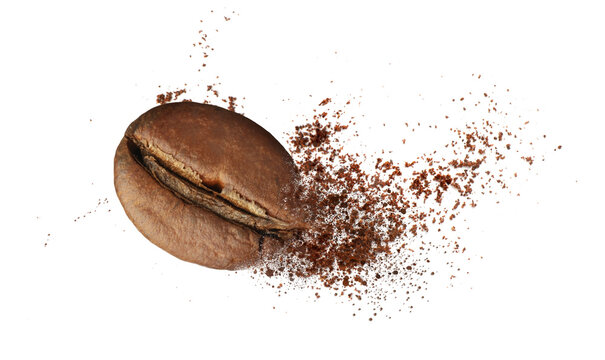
253,76 -> 545,320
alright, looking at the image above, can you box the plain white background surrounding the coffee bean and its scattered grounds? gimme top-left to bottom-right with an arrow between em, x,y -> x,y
0,1 -> 605,359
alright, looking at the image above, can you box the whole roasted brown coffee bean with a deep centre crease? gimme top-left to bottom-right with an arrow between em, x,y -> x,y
114,102 -> 304,269
